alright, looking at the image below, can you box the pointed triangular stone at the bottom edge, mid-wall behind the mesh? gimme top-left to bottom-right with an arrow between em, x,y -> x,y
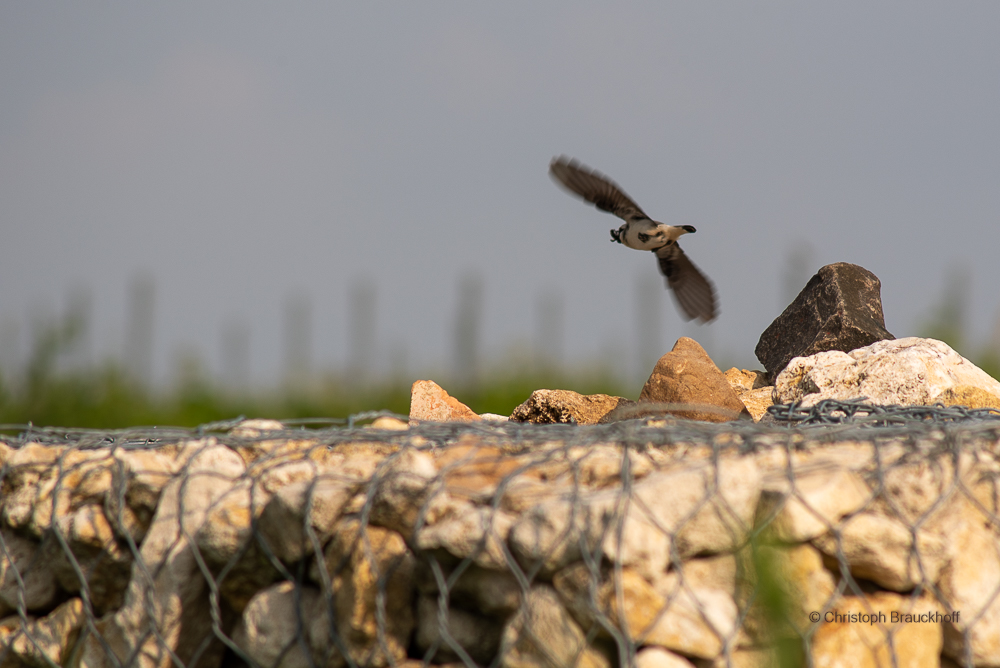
500,584 -> 611,668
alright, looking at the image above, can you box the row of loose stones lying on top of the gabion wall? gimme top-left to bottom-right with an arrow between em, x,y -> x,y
410,263 -> 1000,425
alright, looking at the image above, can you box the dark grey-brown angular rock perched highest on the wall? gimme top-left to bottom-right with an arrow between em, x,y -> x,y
754,262 -> 896,378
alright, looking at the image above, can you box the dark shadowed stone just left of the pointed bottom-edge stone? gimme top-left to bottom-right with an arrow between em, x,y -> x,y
416,596 -> 503,666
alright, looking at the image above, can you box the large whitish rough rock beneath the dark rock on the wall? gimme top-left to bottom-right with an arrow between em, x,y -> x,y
775,337 -> 1000,406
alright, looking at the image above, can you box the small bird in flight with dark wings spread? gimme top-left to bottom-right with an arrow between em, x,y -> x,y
549,156 -> 717,323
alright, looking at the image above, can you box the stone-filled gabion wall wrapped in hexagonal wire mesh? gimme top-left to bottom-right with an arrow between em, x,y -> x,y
0,402 -> 1000,668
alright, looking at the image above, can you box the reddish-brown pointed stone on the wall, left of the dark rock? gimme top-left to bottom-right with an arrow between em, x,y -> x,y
639,336 -> 750,422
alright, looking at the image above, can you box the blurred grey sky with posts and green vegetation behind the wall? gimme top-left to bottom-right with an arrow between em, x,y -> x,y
0,0 -> 1000,427
